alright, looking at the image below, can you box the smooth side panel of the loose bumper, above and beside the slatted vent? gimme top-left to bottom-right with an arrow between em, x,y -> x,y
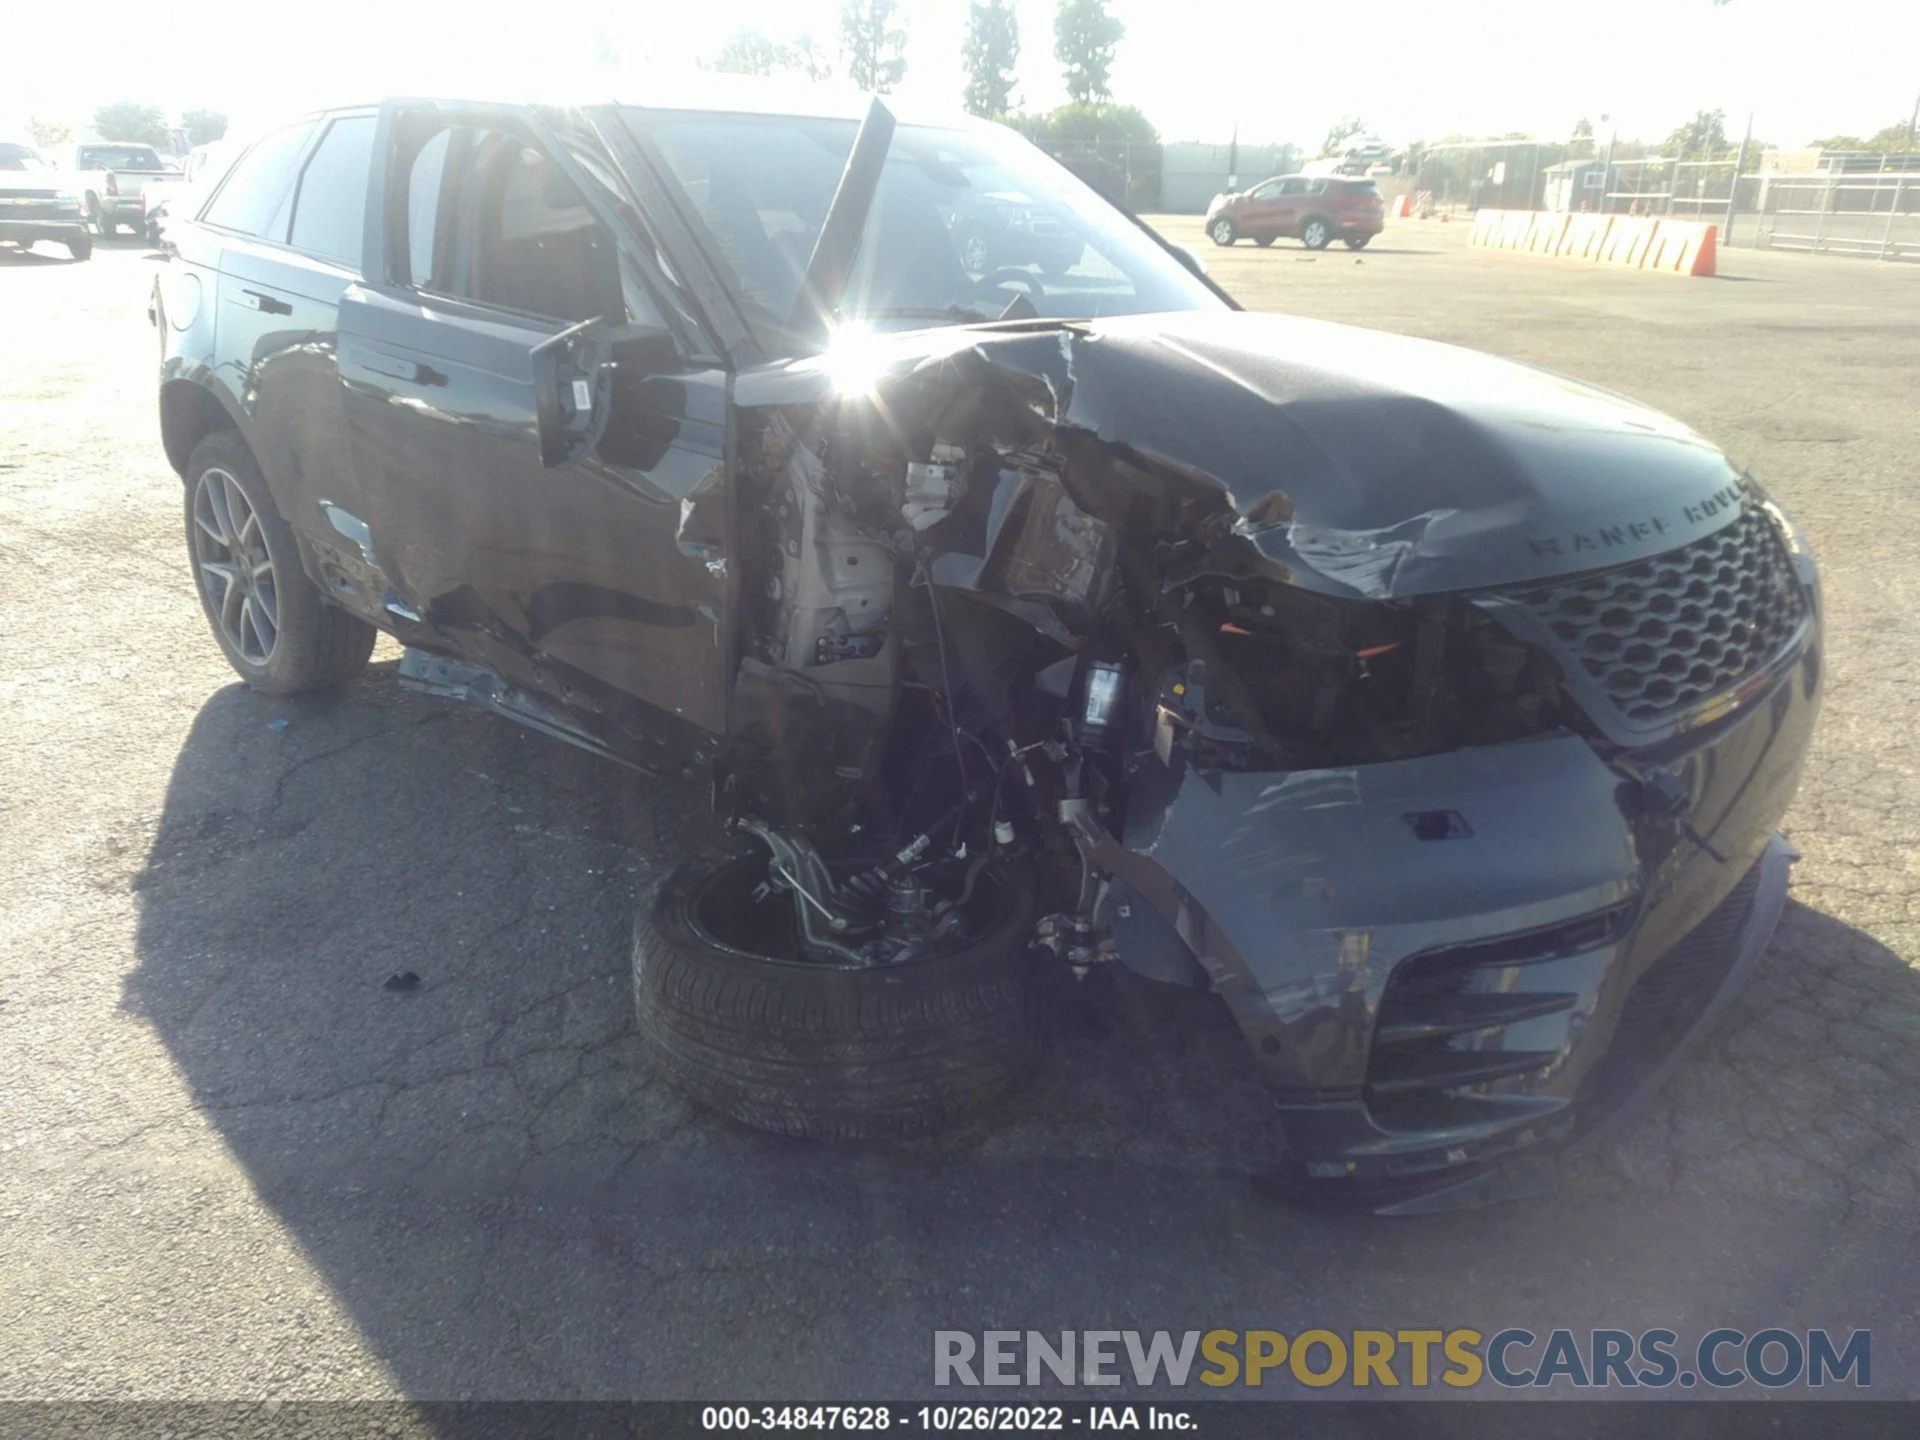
1096,735 -> 1642,1087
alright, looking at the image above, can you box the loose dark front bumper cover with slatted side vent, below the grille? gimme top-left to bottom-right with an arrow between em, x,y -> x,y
1100,628 -> 1820,1213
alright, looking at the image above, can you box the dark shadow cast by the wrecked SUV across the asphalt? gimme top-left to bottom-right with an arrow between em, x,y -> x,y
125,664 -> 1920,1398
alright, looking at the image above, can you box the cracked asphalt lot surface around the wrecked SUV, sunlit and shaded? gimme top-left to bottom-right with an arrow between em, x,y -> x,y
0,219 -> 1920,1400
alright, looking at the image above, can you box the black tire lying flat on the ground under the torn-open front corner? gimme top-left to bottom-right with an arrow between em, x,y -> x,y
634,847 -> 1041,1140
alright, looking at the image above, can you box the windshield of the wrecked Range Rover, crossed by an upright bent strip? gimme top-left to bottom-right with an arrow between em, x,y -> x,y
626,109 -> 1221,345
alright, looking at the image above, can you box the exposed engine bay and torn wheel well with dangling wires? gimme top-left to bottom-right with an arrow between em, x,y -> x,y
722,345 -> 1582,972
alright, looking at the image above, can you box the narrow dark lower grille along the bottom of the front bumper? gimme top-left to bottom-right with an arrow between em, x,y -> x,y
1580,866 -> 1761,1125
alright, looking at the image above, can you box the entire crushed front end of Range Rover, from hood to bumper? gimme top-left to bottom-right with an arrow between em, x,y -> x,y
724,317 -> 1820,1212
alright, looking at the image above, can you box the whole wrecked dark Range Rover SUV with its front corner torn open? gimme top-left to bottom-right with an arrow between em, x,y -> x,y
156,102 -> 1820,1212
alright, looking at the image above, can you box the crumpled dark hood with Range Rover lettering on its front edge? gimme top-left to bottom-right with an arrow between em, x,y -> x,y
739,311 -> 1741,599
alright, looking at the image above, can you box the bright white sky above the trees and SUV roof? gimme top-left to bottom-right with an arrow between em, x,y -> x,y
0,0 -> 1920,146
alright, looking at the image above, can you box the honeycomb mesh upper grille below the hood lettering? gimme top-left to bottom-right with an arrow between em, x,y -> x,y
1513,499 -> 1807,724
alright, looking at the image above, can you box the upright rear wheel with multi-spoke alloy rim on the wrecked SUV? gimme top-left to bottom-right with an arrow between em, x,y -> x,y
186,430 -> 374,695
